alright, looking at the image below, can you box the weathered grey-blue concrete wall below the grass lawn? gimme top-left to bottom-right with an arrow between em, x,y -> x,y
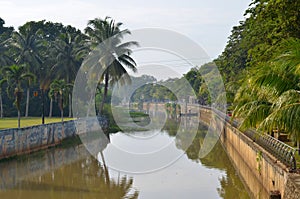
0,118 -> 108,159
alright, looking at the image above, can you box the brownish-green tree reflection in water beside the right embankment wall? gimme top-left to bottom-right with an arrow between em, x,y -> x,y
163,117 -> 249,199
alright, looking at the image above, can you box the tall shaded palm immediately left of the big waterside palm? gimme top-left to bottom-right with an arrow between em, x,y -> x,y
52,29 -> 88,117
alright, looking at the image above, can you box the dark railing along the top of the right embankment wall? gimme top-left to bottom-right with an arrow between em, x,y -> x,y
201,107 -> 297,171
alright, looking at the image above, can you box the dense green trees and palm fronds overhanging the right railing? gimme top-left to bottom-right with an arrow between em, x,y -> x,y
178,0 -> 300,150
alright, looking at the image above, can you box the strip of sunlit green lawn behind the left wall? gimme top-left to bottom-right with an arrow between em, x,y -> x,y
0,117 -> 73,129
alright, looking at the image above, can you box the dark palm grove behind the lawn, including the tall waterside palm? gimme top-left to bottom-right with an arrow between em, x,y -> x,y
0,17 -> 137,126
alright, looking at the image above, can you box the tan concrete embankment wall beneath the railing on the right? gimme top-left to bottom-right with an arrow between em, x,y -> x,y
200,110 -> 300,199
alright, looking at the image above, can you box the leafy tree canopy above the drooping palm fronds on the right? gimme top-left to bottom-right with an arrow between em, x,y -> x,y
215,0 -> 300,102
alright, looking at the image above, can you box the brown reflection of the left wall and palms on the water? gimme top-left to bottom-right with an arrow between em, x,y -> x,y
0,145 -> 138,199
